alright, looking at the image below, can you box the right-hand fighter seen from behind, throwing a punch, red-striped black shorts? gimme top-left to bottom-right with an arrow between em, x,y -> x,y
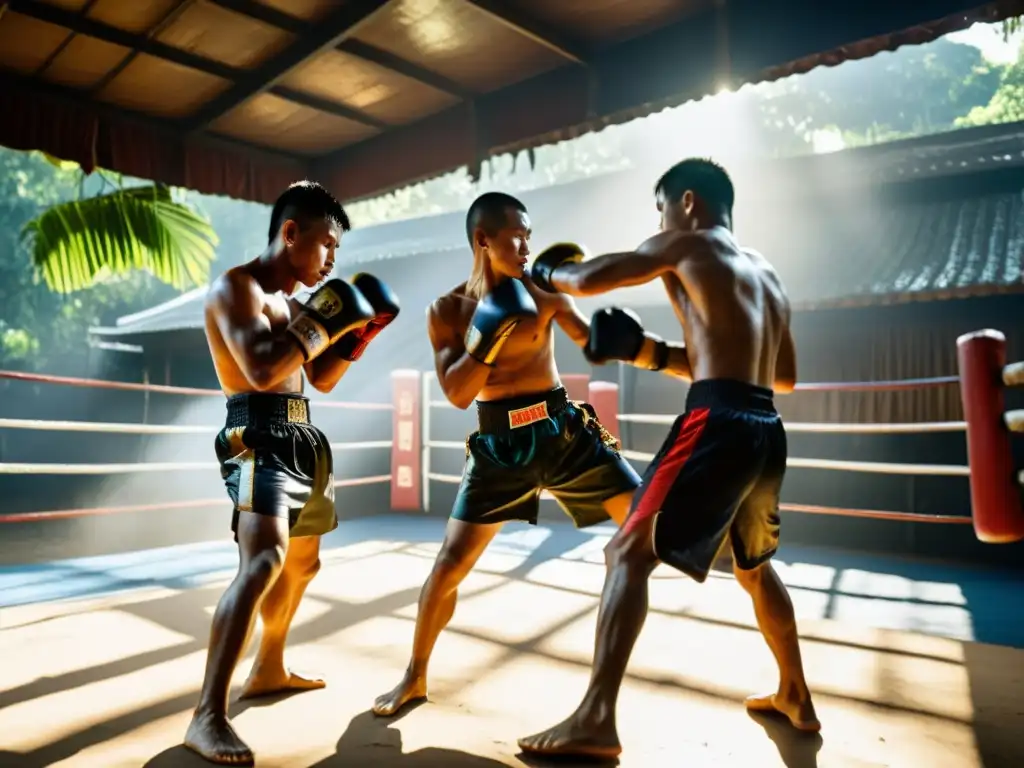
519,160 -> 820,758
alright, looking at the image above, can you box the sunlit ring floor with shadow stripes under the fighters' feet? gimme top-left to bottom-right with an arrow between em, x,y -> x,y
0,516 -> 1024,768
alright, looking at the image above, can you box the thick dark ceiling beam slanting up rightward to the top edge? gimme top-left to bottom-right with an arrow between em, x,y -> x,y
186,0 -> 390,132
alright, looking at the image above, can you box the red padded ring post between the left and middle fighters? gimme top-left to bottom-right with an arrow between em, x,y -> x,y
391,371 -> 424,511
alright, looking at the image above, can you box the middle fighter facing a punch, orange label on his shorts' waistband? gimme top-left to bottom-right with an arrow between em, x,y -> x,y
374,193 -> 640,716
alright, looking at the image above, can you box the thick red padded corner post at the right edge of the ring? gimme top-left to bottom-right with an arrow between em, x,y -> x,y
956,329 -> 1024,544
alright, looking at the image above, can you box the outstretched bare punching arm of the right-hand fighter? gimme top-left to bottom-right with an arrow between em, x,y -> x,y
551,232 -> 685,296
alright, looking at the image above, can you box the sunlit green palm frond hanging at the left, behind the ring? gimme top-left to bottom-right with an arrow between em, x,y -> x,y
22,185 -> 218,293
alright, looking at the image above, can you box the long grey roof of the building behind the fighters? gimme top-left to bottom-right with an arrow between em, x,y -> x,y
92,124 -> 1024,339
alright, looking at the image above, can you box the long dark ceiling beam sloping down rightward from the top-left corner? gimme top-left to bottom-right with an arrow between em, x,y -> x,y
10,0 -> 389,130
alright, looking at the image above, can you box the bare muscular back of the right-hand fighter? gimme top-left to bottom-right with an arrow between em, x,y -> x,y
662,227 -> 790,389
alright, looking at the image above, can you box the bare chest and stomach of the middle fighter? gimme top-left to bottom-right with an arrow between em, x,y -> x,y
437,279 -> 565,401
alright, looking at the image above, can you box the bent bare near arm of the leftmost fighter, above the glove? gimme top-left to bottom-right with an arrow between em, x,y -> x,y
207,272 -> 303,390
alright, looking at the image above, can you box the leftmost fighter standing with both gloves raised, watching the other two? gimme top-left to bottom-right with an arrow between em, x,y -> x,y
184,181 -> 398,765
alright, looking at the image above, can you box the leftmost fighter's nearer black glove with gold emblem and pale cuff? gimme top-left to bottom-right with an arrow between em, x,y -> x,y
288,278 -> 376,362
